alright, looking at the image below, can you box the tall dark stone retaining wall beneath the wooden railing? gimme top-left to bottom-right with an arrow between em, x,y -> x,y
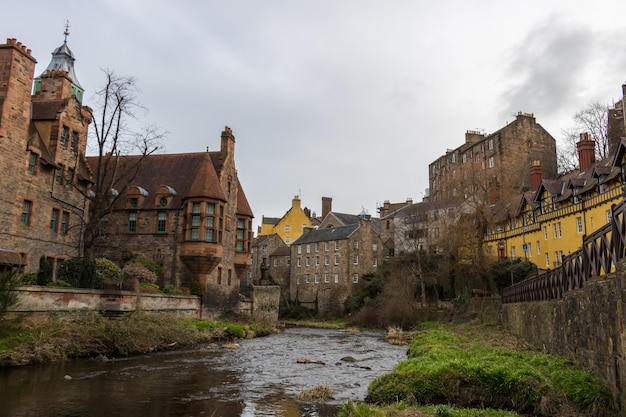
502,272 -> 626,415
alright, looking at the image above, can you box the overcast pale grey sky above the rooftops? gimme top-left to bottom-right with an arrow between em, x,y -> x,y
0,0 -> 626,231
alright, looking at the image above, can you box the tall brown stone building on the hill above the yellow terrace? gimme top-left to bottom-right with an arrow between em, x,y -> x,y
428,113 -> 557,206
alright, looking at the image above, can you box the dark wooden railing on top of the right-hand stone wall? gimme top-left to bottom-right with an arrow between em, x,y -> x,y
502,200 -> 626,303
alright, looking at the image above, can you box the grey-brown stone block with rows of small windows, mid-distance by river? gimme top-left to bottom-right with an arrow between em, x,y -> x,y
290,213 -> 383,312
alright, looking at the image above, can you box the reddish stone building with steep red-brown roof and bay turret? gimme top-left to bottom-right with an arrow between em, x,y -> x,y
88,127 -> 253,310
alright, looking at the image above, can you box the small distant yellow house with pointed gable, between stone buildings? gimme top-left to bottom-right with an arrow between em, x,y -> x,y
257,196 -> 313,245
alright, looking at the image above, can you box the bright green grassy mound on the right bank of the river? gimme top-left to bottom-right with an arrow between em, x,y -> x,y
341,323 -> 615,417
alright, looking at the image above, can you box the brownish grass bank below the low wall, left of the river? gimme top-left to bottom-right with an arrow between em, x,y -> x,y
0,312 -> 278,366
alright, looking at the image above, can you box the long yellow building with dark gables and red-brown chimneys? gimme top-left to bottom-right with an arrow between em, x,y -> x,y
484,135 -> 624,269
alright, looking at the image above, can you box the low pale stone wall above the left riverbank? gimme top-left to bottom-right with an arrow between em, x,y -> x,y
10,286 -> 201,317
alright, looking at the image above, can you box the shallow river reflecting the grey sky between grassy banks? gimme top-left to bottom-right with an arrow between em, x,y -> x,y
0,328 -> 406,417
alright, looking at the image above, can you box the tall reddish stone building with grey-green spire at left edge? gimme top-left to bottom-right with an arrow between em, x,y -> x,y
0,33 -> 92,272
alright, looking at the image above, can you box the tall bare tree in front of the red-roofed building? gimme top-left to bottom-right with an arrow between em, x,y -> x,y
79,70 -> 166,255
